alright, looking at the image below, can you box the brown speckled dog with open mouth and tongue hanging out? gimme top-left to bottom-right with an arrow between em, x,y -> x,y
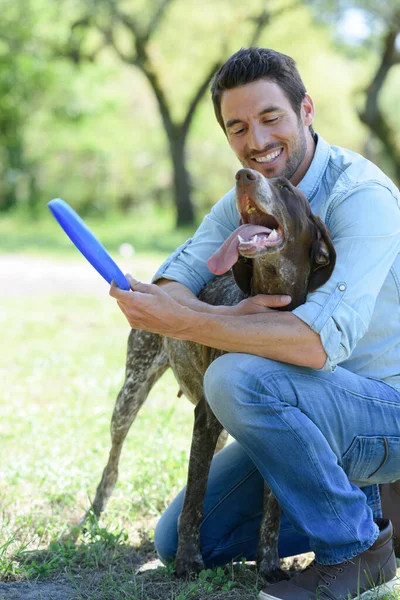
86,169 -> 336,582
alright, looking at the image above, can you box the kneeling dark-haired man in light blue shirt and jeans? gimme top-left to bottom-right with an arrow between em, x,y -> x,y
110,48 -> 400,600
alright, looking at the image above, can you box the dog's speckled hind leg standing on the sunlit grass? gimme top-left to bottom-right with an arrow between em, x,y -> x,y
85,330 -> 169,519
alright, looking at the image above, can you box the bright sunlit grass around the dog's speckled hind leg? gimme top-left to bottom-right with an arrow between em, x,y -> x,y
0,252 -> 192,568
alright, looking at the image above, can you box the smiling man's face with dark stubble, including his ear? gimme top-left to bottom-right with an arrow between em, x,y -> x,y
221,79 -> 314,185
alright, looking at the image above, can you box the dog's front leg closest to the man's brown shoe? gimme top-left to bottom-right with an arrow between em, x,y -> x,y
257,484 -> 289,583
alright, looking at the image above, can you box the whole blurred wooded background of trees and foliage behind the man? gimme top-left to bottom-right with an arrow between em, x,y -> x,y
0,0 -> 400,226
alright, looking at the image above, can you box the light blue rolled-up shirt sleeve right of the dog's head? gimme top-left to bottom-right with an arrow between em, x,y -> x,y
293,183 -> 400,370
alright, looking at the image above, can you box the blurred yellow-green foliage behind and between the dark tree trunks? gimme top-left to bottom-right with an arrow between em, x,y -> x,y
0,0 -> 398,223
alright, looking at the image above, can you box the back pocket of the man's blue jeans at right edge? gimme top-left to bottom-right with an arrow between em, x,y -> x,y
342,435 -> 400,485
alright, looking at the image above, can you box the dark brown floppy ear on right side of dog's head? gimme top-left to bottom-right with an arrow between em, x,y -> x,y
308,215 -> 336,292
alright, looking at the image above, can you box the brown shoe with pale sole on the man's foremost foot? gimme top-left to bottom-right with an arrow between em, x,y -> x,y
258,519 -> 400,600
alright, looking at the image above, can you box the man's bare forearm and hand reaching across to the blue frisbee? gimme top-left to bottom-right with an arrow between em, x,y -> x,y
110,276 -> 327,369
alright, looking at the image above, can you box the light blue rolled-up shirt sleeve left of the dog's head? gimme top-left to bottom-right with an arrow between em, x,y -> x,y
152,189 -> 240,296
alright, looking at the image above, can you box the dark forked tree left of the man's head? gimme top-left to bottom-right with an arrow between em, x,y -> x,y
60,0 -> 292,226
